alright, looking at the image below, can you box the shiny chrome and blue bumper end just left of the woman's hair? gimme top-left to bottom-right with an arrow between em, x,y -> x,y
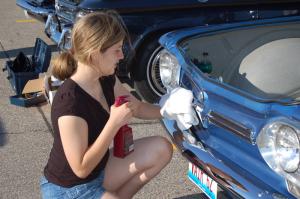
45,14 -> 72,50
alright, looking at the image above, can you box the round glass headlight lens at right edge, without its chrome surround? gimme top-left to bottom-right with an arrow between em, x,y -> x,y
275,125 -> 300,172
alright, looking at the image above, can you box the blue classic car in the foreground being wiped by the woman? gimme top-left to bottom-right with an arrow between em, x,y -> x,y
155,13 -> 300,199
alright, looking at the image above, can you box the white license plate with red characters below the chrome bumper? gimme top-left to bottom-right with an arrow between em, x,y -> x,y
188,162 -> 218,199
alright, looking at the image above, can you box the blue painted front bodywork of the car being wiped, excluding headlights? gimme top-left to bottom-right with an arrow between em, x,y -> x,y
160,17 -> 300,198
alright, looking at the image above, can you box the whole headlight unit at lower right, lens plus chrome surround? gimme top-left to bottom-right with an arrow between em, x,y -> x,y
257,118 -> 300,186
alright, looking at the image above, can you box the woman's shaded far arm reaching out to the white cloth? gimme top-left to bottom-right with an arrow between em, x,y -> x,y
114,77 -> 162,119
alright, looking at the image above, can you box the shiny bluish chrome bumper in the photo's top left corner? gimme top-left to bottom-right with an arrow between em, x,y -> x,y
16,0 -> 55,17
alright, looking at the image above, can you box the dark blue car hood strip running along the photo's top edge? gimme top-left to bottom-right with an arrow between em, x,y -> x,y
78,0 -> 299,12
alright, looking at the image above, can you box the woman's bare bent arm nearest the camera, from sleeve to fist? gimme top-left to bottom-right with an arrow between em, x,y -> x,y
58,103 -> 132,178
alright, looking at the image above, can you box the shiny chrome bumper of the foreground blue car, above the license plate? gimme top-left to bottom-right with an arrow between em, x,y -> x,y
163,119 -> 294,199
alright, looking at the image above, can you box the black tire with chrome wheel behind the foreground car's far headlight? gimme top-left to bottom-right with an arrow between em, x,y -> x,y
132,36 -> 166,103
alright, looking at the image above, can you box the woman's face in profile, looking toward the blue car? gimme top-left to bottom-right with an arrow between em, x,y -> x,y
92,40 -> 124,76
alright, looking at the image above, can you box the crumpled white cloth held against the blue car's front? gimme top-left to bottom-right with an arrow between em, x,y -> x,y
159,87 -> 199,130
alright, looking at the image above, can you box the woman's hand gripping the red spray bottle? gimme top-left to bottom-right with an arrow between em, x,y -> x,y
108,102 -> 133,128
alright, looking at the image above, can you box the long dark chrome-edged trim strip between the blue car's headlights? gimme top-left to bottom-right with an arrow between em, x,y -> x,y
208,111 -> 253,143
